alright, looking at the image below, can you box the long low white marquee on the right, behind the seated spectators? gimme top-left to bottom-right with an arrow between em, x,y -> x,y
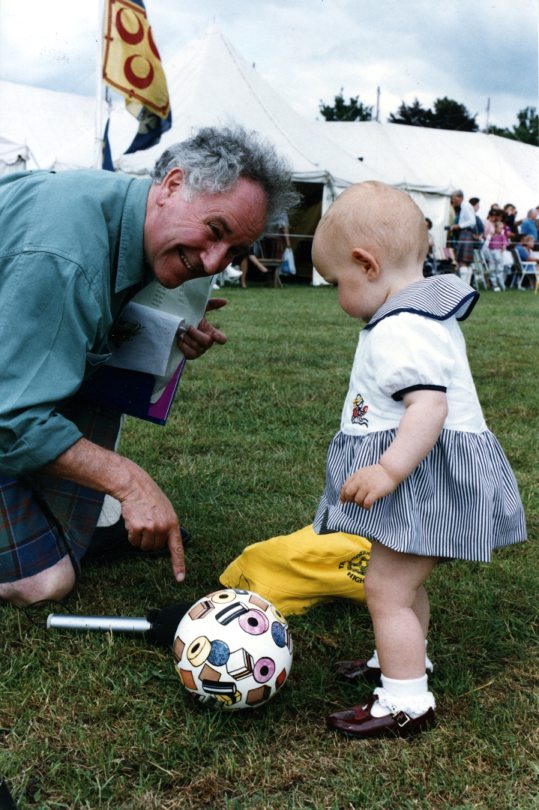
317,121 -> 539,246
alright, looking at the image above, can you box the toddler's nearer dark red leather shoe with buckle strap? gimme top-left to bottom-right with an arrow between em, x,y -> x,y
327,695 -> 435,739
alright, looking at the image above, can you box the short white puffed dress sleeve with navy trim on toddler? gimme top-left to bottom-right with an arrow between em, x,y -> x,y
373,312 -> 454,401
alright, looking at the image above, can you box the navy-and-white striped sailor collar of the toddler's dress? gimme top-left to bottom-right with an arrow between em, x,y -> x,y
365,274 -> 479,329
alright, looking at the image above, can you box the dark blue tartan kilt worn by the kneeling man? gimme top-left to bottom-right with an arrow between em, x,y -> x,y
0,399 -> 121,582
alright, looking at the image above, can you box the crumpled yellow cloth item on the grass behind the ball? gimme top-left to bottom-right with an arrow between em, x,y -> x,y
219,525 -> 371,616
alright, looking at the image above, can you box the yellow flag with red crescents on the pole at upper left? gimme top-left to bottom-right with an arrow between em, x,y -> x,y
103,0 -> 172,154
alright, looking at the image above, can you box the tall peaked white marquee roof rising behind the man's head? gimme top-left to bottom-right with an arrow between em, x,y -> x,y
110,26 -> 380,191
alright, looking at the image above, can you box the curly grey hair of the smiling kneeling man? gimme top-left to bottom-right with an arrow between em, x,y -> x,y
152,127 -> 300,225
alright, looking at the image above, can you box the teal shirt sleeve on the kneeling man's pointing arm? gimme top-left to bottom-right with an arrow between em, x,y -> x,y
0,251 -> 100,470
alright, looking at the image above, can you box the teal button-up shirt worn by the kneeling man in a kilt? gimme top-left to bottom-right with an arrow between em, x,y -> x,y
0,170 -> 150,477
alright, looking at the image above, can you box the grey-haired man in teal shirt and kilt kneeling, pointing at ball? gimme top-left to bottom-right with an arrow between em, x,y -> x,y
0,128 -> 296,606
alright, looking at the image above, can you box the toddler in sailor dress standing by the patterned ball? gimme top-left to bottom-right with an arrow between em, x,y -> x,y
313,182 -> 526,738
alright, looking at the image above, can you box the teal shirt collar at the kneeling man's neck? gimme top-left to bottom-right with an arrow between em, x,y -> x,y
115,179 -> 152,292
